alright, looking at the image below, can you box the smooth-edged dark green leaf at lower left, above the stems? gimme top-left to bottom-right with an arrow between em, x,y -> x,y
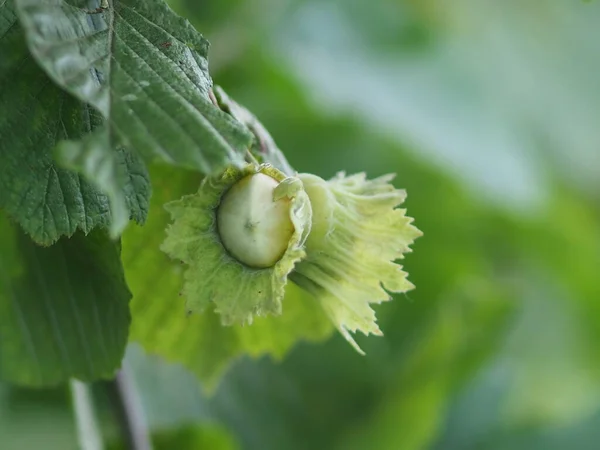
0,216 -> 131,386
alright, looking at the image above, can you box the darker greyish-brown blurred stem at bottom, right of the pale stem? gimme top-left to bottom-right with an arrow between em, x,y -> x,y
106,362 -> 152,450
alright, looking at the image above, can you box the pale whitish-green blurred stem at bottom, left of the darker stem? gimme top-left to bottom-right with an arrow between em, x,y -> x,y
69,379 -> 104,450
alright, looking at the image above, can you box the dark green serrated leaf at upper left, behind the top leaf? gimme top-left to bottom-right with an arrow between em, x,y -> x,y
0,1 -> 150,245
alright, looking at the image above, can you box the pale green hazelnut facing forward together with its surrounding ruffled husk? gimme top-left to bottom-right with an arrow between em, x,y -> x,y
161,164 -> 312,325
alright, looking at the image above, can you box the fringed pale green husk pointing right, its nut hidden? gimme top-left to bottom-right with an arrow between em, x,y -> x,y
292,173 -> 422,353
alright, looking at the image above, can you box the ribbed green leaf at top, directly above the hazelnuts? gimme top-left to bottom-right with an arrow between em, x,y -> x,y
16,0 -> 251,173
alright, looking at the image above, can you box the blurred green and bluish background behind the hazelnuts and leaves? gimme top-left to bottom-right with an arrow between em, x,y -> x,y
0,0 -> 600,450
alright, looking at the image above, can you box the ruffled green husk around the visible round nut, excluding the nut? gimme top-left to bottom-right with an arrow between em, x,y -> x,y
161,164 -> 311,325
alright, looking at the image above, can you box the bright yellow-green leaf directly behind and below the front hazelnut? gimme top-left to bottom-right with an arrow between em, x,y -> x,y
123,166 -> 333,387
